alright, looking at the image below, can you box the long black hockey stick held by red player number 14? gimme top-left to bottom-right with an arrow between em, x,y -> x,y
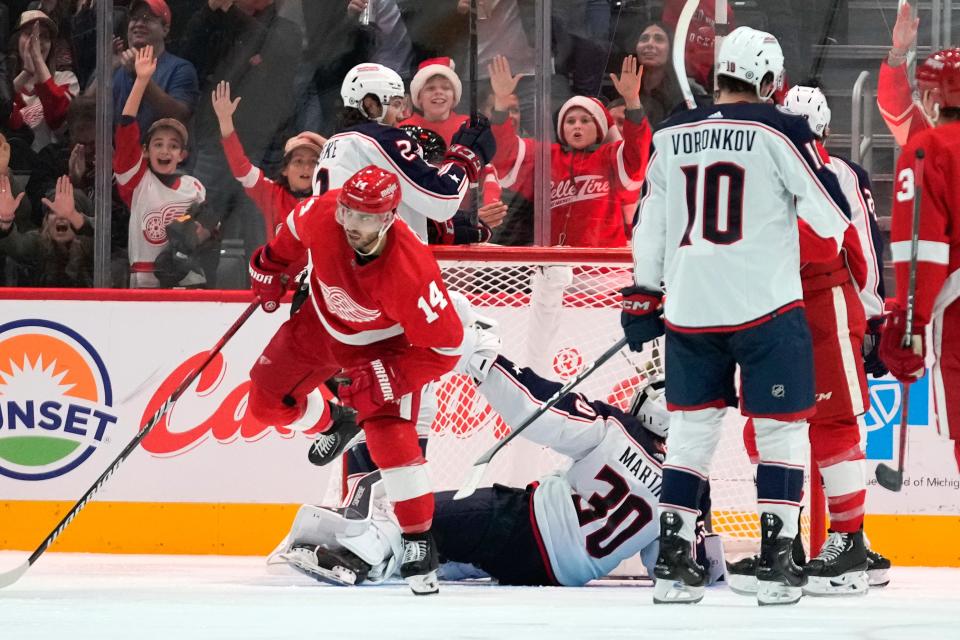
0,298 -> 260,589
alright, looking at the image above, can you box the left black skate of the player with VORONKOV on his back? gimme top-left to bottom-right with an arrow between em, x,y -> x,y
653,511 -> 707,604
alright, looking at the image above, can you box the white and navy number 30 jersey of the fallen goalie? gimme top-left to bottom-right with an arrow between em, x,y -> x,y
480,356 -> 663,586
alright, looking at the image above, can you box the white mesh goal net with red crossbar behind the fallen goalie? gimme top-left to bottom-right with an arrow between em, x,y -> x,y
334,247 -> 810,568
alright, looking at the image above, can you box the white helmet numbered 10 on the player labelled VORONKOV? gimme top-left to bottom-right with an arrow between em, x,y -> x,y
716,27 -> 783,100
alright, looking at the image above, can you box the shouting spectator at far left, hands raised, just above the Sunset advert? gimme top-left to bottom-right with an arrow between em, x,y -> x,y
0,175 -> 93,287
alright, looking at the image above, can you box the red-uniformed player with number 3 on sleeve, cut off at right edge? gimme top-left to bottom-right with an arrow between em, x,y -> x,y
880,48 -> 960,467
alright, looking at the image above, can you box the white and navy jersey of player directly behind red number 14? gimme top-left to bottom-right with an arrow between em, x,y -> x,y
313,122 -> 469,242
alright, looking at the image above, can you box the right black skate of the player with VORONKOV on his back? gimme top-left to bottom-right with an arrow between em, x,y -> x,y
757,513 -> 807,606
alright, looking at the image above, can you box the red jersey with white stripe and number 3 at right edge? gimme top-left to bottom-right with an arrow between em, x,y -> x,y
890,122 -> 960,326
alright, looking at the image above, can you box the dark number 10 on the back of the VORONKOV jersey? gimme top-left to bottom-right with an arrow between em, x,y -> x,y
680,162 -> 745,247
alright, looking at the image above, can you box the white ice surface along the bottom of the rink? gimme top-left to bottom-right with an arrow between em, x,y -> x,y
0,552 -> 960,640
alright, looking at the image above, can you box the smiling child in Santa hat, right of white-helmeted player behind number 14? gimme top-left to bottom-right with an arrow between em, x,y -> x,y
400,58 -> 470,145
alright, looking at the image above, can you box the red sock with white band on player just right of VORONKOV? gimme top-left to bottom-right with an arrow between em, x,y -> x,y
810,416 -> 867,533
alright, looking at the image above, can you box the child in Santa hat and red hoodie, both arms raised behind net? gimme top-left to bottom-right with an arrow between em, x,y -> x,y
489,56 -> 651,247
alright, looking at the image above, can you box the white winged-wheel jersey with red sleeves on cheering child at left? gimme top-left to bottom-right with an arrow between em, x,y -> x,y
113,117 -> 207,288
